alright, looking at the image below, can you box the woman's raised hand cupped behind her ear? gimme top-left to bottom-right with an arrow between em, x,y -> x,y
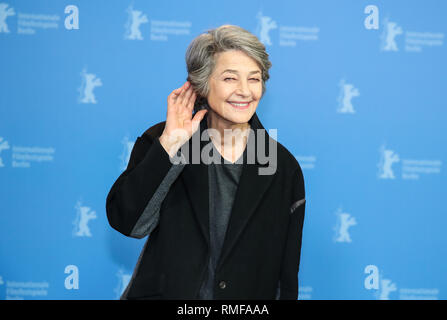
160,81 -> 207,157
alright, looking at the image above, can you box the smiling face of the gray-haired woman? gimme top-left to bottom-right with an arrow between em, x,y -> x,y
207,50 -> 262,123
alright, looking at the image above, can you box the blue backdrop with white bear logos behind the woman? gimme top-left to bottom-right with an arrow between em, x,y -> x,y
0,0 -> 447,299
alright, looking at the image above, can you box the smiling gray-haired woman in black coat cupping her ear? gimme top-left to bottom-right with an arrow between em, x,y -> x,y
106,25 -> 305,299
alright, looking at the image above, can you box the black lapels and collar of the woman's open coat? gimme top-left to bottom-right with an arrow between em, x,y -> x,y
182,113 -> 275,270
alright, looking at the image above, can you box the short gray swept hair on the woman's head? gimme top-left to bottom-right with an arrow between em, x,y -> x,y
185,25 -> 272,111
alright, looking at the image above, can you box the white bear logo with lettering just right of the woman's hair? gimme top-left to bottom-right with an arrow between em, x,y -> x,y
255,11 -> 320,47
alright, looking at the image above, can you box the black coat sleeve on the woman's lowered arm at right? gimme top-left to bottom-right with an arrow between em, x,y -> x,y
278,166 -> 306,300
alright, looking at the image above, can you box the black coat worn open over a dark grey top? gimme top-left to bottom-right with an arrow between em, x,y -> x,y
106,113 -> 305,300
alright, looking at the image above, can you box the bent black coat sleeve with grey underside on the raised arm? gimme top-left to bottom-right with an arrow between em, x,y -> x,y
106,135 -> 184,239
